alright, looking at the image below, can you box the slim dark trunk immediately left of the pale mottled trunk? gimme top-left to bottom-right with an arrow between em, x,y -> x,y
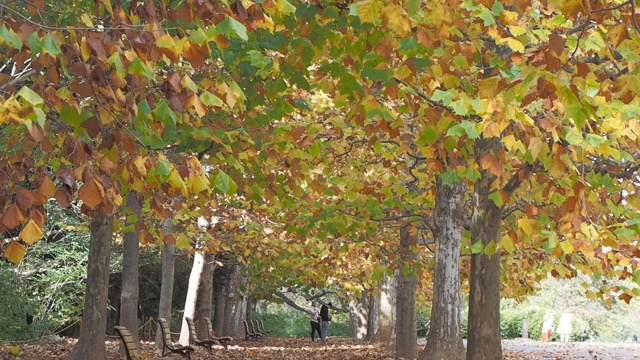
396,226 -> 418,359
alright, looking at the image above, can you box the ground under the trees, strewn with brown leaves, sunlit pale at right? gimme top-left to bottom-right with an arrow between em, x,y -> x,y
0,337 -> 640,360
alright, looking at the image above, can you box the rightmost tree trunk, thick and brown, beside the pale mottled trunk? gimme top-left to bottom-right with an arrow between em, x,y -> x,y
467,169 -> 502,360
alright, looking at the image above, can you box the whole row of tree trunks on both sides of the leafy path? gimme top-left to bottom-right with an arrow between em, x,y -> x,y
68,160 -> 502,360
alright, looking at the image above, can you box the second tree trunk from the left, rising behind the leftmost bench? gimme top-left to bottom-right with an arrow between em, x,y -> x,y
119,191 -> 140,354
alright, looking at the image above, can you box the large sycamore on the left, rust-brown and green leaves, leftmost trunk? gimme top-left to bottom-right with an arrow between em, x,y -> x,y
0,1 -> 310,358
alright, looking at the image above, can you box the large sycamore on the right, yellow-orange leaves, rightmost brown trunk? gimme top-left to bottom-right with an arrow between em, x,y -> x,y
268,0 -> 639,359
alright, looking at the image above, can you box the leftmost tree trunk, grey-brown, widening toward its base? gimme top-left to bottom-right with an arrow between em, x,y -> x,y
67,210 -> 113,360
